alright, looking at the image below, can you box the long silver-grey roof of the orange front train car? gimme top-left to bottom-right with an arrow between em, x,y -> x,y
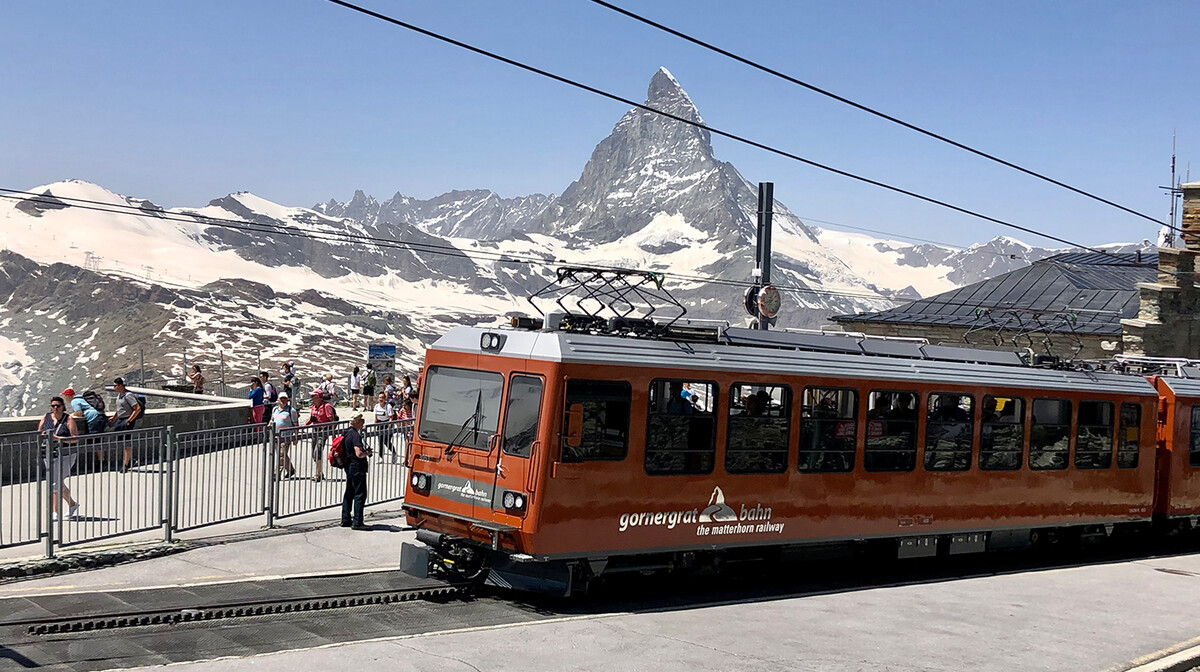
431,326 -> 1152,396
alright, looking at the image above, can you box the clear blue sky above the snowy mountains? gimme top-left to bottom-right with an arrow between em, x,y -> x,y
0,0 -> 1200,245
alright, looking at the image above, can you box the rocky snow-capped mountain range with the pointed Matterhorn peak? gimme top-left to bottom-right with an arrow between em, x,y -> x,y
0,70 -> 1113,413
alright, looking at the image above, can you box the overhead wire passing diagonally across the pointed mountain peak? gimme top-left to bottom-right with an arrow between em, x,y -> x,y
328,0 -> 1132,254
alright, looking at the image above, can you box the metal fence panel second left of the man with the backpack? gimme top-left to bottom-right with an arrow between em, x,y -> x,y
169,424 -> 270,530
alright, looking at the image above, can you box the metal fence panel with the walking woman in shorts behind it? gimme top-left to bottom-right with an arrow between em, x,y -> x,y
47,427 -> 169,546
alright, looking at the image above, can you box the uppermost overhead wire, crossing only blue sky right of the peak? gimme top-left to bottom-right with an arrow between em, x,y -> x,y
590,0 -> 1175,228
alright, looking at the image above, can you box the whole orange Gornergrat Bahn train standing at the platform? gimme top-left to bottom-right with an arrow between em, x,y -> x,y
401,314 -> 1200,594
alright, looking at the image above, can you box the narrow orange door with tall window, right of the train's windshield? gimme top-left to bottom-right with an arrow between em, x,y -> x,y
492,373 -> 545,516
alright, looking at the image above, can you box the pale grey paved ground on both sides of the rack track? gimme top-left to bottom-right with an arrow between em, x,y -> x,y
7,516 -> 1200,672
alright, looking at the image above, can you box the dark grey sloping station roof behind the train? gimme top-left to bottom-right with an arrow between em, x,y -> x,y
832,252 -> 1158,336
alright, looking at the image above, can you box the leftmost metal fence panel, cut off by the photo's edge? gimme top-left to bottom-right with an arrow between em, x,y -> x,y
0,432 -> 46,548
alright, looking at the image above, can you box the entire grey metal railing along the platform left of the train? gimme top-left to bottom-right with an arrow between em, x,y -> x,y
0,420 -> 413,557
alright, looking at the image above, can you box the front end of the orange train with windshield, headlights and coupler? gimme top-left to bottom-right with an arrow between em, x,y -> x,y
401,328 -> 570,594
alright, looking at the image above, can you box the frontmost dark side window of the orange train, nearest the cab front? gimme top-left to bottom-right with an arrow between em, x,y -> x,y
562,379 -> 634,462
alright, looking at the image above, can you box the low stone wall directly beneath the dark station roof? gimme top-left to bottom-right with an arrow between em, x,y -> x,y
841,322 -> 1121,359
